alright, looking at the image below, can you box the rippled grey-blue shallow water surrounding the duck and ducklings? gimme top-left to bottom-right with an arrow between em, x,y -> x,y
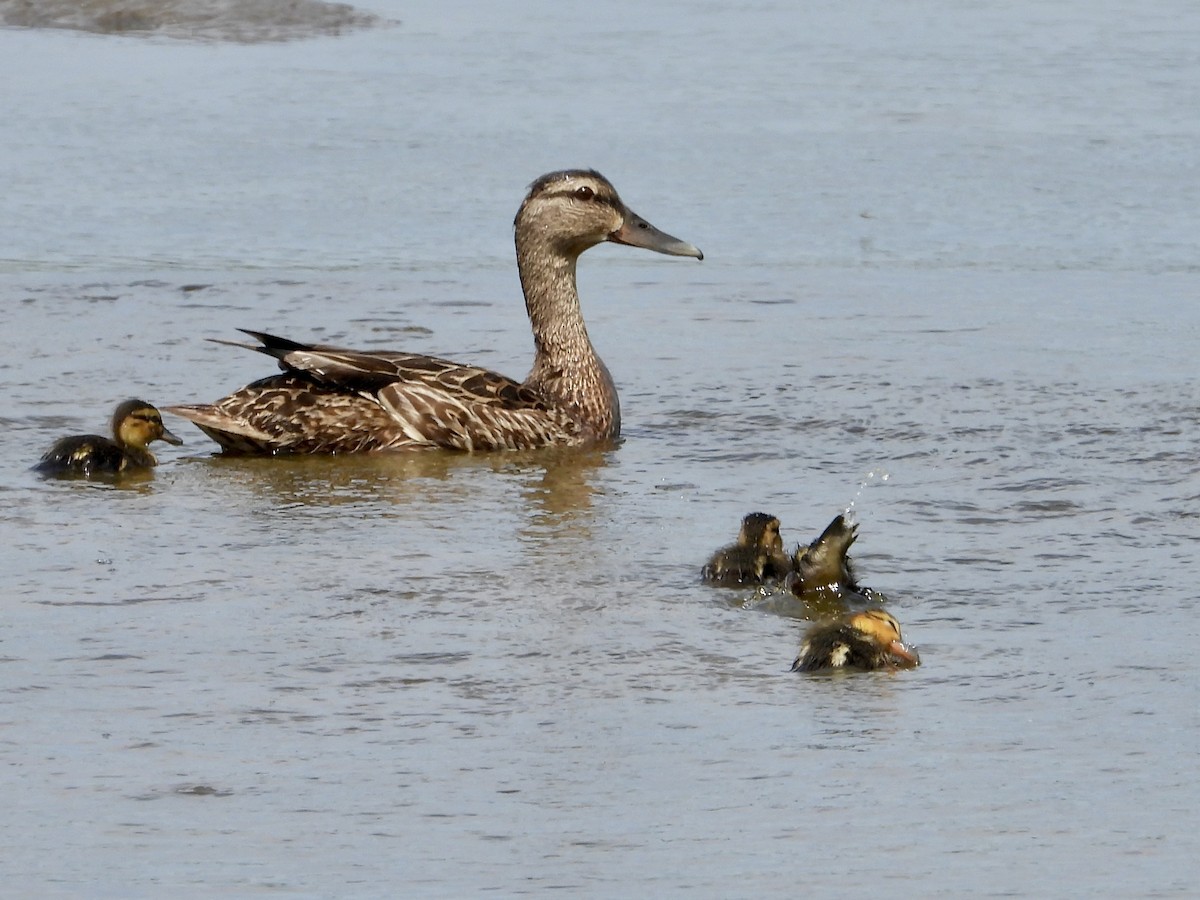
0,2 -> 1200,898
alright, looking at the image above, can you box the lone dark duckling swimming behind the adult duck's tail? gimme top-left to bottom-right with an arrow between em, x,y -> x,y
34,400 -> 184,478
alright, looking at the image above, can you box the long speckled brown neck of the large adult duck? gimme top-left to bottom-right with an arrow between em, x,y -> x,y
517,235 -> 620,440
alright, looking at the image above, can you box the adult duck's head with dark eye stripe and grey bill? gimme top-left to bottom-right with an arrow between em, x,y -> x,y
514,169 -> 704,259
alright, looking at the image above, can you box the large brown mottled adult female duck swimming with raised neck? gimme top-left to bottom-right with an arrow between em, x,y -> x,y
167,169 -> 704,454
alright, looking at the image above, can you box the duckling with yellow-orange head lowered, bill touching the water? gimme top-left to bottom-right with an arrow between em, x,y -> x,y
792,608 -> 920,672
